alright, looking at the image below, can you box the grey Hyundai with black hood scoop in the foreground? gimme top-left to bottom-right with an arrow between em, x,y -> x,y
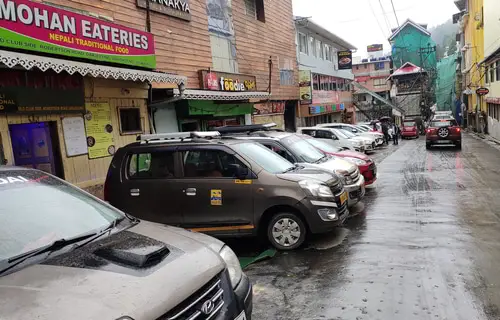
0,166 -> 252,320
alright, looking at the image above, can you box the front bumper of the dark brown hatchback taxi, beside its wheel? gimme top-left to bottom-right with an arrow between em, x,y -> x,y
298,198 -> 349,233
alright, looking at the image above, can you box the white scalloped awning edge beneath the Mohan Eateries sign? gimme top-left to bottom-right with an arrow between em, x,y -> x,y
0,50 -> 187,84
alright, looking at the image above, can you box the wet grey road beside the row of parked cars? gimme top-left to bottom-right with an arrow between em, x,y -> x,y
236,134 -> 500,320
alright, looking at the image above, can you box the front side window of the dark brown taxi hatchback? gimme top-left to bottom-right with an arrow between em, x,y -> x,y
183,150 -> 246,178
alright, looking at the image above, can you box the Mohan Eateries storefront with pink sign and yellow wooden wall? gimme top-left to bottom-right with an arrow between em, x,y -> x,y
0,0 -> 186,195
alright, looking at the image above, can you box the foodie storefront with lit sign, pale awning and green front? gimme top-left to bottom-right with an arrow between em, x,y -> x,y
153,70 -> 269,132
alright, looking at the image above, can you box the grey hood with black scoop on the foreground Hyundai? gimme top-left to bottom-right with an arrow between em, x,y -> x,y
0,222 -> 225,320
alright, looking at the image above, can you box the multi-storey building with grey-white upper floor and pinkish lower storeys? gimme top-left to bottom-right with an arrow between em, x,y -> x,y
295,17 -> 356,126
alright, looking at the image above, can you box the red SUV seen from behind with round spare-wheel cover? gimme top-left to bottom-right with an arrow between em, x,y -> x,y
425,118 -> 462,149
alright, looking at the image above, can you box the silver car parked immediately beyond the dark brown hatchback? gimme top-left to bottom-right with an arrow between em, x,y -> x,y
217,125 -> 365,207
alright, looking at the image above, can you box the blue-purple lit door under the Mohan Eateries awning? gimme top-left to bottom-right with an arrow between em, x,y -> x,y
9,122 -> 60,176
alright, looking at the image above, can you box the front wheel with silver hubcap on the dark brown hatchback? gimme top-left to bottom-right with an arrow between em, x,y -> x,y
267,213 -> 307,250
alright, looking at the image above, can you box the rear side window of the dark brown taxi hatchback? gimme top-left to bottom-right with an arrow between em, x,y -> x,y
128,151 -> 175,179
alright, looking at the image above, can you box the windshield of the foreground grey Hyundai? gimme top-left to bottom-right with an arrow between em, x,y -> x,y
0,170 -> 124,260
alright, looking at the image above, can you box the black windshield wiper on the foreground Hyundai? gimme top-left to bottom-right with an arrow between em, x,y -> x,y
0,218 -> 125,275
